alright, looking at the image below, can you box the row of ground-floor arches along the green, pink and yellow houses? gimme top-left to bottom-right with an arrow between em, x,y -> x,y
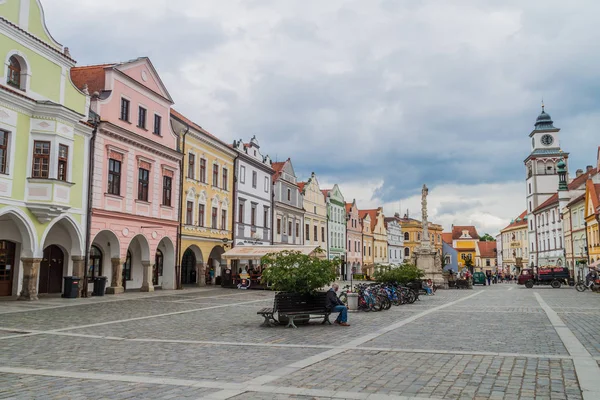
0,207 -> 224,300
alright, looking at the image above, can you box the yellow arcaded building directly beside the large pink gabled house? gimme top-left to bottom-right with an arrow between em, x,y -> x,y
171,110 -> 236,286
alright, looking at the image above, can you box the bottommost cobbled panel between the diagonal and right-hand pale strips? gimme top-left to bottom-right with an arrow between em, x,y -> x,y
274,351 -> 582,399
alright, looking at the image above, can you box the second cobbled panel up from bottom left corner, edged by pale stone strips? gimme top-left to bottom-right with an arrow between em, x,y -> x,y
1,335 -> 319,382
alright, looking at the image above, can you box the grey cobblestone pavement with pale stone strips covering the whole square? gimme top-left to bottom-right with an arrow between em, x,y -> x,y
0,284 -> 600,400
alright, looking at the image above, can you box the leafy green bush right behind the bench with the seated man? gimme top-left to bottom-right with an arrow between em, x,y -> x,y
261,250 -> 340,294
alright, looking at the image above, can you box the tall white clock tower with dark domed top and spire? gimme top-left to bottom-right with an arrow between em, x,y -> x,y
525,104 -> 569,266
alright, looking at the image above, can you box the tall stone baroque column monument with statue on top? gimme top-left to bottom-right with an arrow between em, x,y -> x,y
412,185 -> 448,288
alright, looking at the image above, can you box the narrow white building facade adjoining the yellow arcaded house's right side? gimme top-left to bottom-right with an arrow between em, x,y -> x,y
233,137 -> 273,252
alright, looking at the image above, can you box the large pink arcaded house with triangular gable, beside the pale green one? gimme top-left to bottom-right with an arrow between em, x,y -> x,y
71,58 -> 181,294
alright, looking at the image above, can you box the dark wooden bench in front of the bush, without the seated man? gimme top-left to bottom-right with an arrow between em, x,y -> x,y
257,292 -> 331,328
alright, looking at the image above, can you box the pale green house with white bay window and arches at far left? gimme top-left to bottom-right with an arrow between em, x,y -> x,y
0,0 -> 93,300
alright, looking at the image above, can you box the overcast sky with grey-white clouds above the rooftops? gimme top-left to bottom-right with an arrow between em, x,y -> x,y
42,0 -> 600,234
